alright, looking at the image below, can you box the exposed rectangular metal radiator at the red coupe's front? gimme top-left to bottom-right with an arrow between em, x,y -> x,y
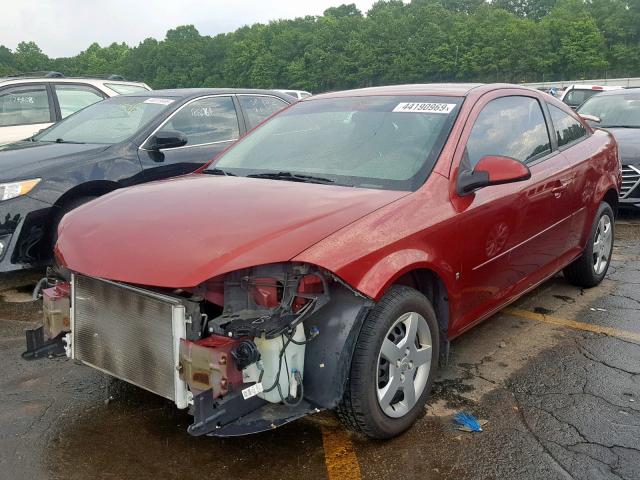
71,275 -> 187,408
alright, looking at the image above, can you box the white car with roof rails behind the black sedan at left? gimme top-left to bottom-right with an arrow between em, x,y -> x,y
0,72 -> 151,145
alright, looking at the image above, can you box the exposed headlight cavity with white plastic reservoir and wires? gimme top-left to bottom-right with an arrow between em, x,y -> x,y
179,264 -> 333,435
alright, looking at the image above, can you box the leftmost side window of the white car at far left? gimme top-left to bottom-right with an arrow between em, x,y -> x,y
0,85 -> 53,127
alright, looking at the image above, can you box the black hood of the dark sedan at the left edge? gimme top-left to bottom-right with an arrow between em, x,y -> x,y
0,141 -> 109,181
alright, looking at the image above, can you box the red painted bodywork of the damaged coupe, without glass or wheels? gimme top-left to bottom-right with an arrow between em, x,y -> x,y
57,85 -> 620,337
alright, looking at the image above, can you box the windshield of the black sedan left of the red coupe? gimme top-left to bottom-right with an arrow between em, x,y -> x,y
33,97 -> 174,145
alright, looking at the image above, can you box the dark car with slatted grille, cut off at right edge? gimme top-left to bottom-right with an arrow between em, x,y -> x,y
578,88 -> 640,208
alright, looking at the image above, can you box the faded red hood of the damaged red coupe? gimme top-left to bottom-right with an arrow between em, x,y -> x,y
56,174 -> 408,288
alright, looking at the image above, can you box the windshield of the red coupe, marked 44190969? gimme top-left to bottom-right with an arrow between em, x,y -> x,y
207,96 -> 462,190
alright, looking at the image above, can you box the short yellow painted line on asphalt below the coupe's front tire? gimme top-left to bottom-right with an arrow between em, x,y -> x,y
322,426 -> 361,480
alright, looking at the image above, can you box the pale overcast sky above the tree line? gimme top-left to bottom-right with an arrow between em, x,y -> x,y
0,0 -> 374,58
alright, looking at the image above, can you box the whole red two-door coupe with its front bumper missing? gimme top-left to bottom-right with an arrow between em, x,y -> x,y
32,84 -> 621,438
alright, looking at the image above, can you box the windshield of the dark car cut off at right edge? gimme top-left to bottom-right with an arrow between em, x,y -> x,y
578,93 -> 640,128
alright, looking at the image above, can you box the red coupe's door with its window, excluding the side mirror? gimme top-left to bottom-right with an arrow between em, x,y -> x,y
452,91 -> 570,332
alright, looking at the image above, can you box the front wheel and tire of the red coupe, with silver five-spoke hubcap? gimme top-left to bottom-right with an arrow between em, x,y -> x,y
336,285 -> 440,439
